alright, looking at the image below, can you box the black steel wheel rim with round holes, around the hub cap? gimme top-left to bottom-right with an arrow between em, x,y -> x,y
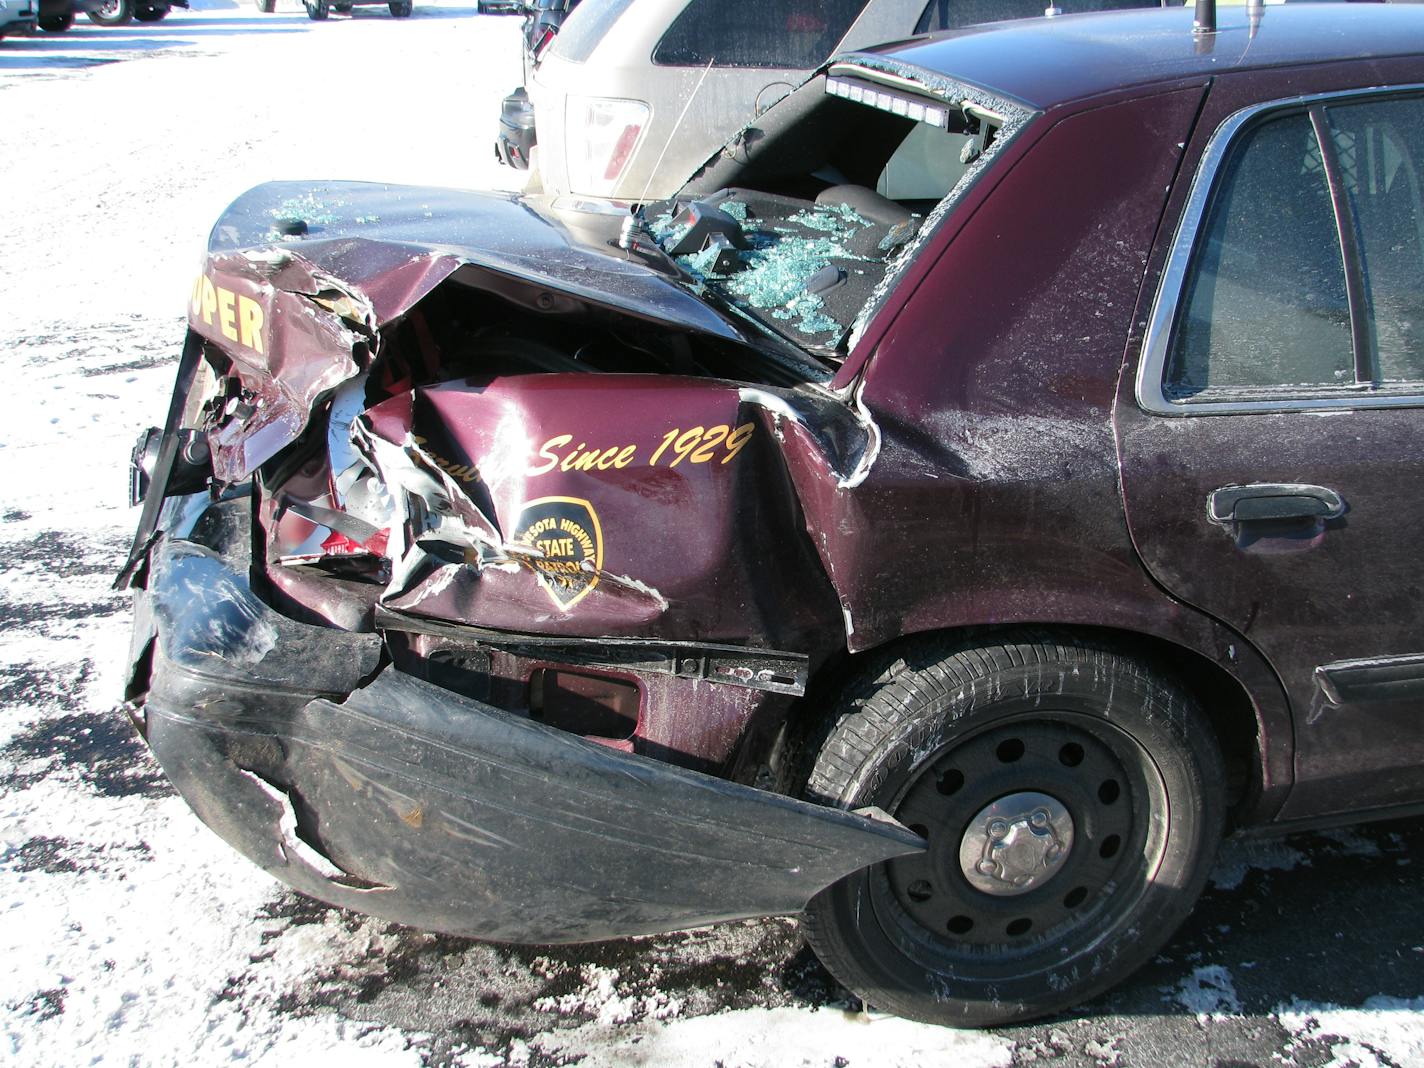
869,711 -> 1168,978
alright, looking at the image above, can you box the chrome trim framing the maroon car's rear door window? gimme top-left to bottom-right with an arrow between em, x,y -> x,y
1136,83 -> 1424,416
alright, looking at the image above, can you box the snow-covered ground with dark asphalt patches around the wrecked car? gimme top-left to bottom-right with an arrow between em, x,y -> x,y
0,8 -> 1424,1068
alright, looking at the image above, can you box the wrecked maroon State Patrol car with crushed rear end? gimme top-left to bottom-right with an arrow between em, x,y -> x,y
120,4 -> 1424,1025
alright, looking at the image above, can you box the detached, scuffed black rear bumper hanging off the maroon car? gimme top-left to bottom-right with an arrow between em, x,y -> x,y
135,501 -> 924,943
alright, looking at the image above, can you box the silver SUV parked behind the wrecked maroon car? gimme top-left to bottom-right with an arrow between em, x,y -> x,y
496,0 -> 1156,199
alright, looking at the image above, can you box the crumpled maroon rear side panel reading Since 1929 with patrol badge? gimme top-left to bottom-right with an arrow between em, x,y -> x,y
343,376 -> 848,648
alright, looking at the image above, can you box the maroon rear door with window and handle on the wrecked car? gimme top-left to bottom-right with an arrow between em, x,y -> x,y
1118,70 -> 1424,817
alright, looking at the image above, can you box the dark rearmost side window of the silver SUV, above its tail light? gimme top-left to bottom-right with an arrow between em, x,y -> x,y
652,0 -> 866,70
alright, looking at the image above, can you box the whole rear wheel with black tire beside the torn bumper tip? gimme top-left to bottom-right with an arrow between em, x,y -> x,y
805,635 -> 1225,1027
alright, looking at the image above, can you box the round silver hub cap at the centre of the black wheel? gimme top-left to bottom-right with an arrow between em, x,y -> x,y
960,790 -> 1072,897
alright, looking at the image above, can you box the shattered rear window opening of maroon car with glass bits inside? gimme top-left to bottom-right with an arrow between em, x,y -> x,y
649,67 -> 1017,357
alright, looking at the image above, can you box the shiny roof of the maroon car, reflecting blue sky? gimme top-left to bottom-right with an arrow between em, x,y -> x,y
848,3 -> 1424,110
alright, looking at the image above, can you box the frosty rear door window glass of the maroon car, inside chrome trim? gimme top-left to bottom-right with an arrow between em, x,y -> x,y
1163,97 -> 1424,402
